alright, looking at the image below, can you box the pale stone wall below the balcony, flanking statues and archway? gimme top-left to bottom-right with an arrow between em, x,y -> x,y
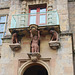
0,35 -> 73,75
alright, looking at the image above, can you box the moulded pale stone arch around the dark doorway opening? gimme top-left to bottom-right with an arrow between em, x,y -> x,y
18,60 -> 51,75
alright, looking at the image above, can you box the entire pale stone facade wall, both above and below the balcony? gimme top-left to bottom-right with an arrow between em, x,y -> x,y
0,0 -> 74,75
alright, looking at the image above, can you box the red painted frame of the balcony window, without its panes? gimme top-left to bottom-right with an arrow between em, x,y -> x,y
28,5 -> 47,25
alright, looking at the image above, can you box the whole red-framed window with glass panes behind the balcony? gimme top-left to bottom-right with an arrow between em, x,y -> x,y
29,4 -> 47,25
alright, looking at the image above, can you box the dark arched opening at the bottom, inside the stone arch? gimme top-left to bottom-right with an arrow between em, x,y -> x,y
23,65 -> 48,75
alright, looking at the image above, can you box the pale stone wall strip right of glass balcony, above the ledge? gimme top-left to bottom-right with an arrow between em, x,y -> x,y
57,0 -> 69,31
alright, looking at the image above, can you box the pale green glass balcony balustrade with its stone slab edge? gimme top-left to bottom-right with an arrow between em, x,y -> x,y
9,11 -> 60,32
